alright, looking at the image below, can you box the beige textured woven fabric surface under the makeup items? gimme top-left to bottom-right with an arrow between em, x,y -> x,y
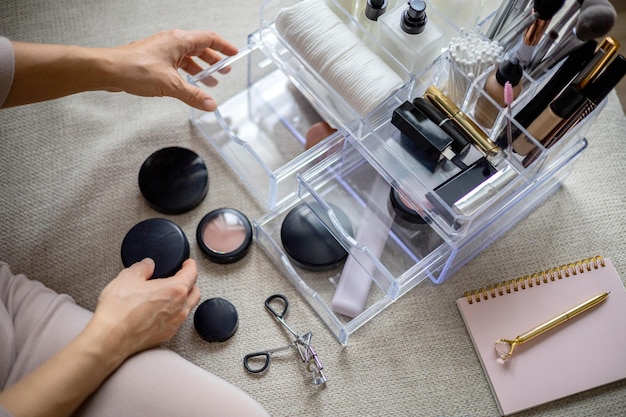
0,0 -> 626,416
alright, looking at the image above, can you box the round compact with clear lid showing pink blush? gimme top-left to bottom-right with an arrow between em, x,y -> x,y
196,208 -> 252,264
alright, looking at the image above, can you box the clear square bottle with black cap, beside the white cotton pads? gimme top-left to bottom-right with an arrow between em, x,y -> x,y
378,0 -> 444,73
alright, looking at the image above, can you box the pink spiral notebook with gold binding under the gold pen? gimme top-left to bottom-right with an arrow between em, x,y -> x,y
457,257 -> 626,415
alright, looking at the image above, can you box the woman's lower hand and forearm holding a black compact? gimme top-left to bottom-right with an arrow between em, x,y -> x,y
0,259 -> 200,417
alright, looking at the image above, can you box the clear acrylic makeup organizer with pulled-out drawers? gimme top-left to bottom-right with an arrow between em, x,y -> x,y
191,0 -> 602,344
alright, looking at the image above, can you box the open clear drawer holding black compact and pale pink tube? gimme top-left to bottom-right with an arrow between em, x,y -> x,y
255,141 -> 449,344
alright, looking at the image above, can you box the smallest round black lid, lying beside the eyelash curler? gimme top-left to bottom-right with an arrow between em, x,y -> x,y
193,297 -> 239,342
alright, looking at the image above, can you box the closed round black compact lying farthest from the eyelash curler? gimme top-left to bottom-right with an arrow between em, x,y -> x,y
139,147 -> 209,214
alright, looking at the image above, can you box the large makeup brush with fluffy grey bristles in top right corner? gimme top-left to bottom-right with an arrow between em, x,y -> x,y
531,0 -> 617,78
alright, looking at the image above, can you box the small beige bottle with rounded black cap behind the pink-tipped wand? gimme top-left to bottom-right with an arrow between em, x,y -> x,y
474,58 -> 522,129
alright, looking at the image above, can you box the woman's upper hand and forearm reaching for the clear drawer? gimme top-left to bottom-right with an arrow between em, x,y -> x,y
4,30 -> 237,111
